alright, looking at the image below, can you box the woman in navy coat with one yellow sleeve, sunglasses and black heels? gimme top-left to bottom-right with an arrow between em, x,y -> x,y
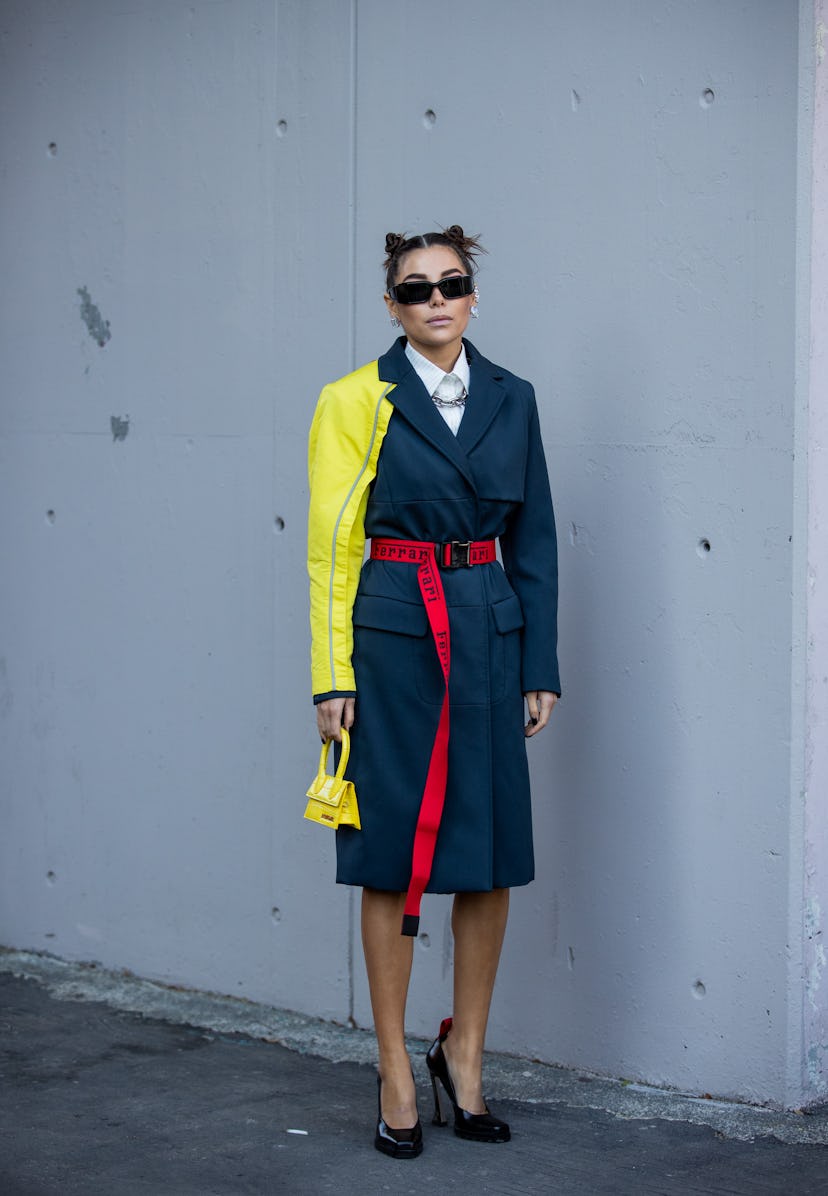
309,225 -> 560,1158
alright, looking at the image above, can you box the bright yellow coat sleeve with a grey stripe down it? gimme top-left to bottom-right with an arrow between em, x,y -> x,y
308,361 -> 394,701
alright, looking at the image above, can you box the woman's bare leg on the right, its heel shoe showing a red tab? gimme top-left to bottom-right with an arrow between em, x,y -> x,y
442,889 -> 509,1113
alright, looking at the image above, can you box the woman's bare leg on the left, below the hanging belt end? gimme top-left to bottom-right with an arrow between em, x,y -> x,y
363,889 -> 416,1129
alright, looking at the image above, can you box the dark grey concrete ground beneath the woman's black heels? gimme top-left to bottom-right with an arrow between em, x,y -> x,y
0,951 -> 828,1196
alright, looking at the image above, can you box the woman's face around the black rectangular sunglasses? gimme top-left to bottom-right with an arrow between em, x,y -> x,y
385,245 -> 475,360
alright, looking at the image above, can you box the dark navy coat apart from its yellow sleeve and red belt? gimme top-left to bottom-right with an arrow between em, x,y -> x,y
336,337 -> 560,892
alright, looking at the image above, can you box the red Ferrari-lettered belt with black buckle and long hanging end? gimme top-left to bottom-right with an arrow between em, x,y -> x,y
371,537 -> 497,936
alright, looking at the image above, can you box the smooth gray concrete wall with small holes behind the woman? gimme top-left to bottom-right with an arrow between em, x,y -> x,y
0,0 -> 828,1105
